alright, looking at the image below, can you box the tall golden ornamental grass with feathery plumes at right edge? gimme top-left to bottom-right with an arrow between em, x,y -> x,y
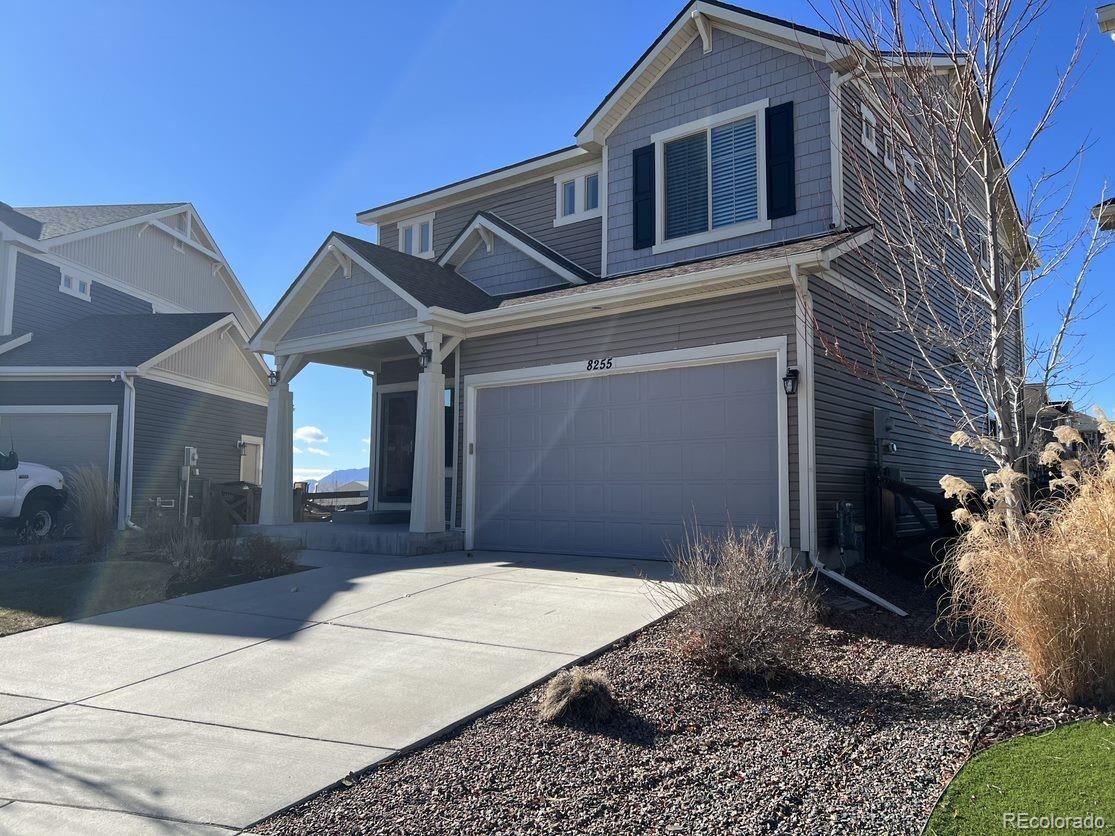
941,420 -> 1115,703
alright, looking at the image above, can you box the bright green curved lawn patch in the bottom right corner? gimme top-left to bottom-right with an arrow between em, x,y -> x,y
927,720 -> 1115,836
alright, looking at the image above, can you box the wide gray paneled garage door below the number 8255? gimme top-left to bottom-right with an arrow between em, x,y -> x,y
474,358 -> 779,557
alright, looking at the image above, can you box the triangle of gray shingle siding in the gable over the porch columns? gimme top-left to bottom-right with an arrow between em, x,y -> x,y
283,264 -> 417,340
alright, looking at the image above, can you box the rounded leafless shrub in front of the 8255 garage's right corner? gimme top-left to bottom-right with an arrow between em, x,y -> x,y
660,527 -> 818,681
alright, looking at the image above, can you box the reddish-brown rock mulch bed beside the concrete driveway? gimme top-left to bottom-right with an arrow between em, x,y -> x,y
253,572 -> 1057,835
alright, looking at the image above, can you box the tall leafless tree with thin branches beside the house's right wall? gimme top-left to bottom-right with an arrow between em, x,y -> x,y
821,0 -> 1105,518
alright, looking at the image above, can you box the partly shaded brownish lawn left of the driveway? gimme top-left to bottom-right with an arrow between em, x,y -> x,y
0,561 -> 174,635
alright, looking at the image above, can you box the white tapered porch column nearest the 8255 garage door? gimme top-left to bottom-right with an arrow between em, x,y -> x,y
410,333 -> 445,533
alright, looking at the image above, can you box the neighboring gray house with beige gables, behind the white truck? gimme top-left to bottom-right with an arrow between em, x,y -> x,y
0,203 -> 268,526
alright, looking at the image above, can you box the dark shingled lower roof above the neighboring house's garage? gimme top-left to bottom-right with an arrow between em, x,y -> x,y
0,313 -> 229,368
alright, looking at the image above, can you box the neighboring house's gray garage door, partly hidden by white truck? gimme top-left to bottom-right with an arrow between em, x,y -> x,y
0,407 -> 116,474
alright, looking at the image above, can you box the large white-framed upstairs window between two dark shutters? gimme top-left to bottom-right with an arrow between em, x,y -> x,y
651,99 -> 770,252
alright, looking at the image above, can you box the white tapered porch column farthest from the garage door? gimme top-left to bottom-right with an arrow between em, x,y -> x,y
260,357 -> 303,525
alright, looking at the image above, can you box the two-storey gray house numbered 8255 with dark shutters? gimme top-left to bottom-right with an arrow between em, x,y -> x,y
251,1 -> 1021,566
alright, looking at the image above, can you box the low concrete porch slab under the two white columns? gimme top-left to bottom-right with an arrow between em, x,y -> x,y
236,523 -> 465,557
